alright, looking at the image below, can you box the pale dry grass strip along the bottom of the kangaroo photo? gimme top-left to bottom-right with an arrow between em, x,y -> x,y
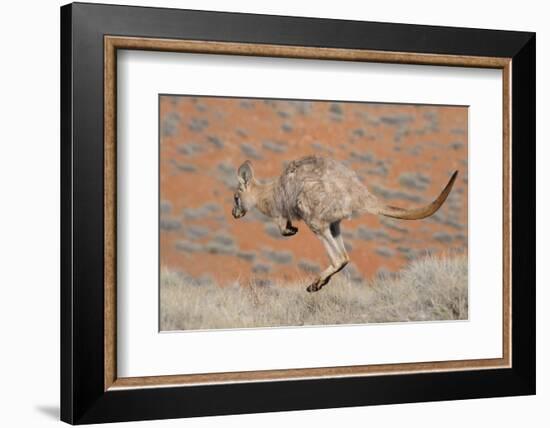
160,255 -> 468,331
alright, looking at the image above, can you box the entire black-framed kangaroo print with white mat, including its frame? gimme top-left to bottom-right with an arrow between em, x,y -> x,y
61,3 -> 535,424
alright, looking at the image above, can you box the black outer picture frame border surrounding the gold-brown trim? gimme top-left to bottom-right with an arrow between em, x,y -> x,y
61,3 -> 536,424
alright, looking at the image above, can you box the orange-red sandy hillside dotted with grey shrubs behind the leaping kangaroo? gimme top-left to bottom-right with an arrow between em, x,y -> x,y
160,96 -> 468,284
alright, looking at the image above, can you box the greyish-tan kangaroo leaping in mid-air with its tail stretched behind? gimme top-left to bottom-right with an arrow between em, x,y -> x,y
232,156 -> 458,292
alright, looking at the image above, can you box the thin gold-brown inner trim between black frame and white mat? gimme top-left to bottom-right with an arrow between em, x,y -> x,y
104,36 -> 512,391
